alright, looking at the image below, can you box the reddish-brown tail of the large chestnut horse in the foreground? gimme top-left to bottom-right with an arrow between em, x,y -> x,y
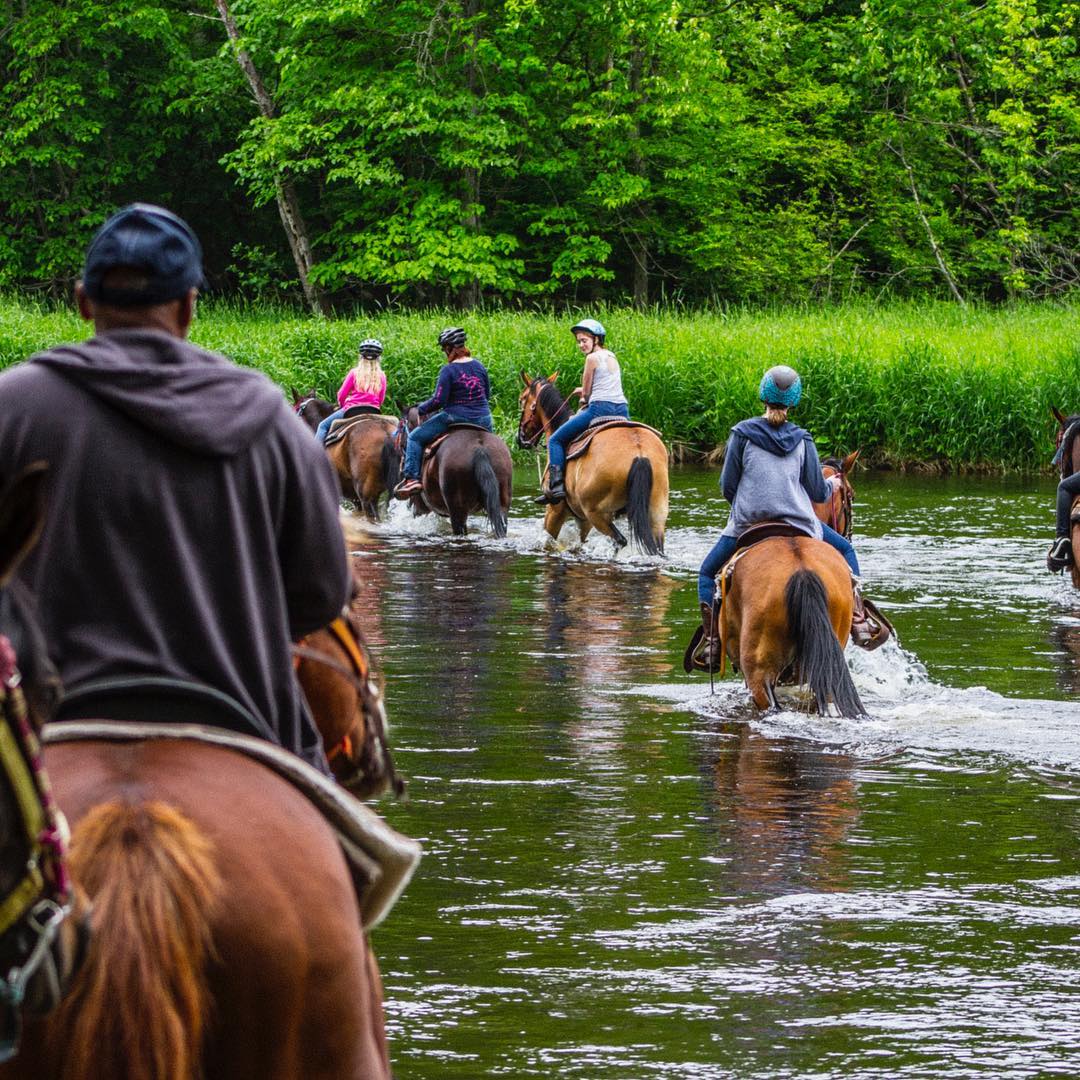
58,801 -> 222,1080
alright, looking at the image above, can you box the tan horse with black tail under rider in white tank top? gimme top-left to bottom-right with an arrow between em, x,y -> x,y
517,370 -> 669,555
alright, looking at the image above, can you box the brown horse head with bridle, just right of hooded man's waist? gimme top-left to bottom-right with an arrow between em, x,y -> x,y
293,610 -> 405,798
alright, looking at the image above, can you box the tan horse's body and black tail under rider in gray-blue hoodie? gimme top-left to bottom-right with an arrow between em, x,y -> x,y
718,536 -> 865,716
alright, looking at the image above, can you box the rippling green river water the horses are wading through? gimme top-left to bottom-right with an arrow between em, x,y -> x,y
354,469 -> 1080,1080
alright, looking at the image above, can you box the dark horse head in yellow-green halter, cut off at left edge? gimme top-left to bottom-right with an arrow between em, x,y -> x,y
0,462 -> 84,1045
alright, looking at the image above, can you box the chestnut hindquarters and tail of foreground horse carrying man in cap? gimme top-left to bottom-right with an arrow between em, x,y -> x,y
0,468 -> 406,1080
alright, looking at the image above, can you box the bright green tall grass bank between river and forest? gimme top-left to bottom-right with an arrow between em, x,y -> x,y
0,299 -> 1080,470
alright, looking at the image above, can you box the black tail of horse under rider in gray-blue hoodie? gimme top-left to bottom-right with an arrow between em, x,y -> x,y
784,570 -> 866,716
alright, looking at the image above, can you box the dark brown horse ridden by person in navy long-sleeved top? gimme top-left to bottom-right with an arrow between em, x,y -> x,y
396,408 -> 514,538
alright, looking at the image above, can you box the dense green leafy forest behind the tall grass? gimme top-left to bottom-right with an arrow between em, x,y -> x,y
0,0 -> 1080,310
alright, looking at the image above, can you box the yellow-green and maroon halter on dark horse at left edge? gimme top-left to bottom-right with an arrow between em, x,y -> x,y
0,635 -> 72,1062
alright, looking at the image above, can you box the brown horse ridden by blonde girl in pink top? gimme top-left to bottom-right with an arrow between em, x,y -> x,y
293,390 -> 402,522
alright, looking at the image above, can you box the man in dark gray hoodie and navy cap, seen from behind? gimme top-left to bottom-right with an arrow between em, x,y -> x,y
0,204 -> 349,771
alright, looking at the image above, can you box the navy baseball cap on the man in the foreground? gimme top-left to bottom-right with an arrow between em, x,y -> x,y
82,203 -> 204,308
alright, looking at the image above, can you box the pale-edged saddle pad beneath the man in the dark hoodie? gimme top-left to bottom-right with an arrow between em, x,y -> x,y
41,720 -> 420,930
